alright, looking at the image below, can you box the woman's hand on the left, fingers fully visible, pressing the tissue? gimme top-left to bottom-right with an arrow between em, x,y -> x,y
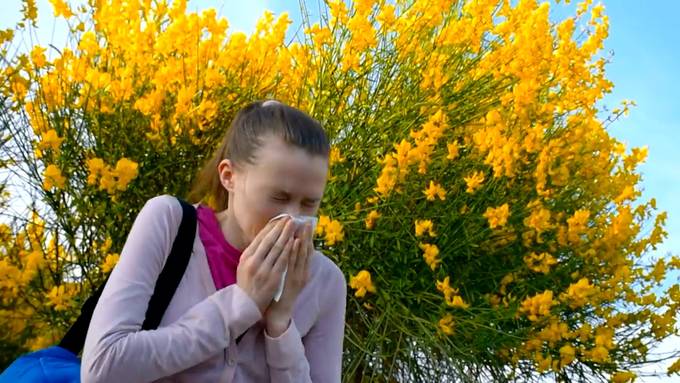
236,217 -> 295,315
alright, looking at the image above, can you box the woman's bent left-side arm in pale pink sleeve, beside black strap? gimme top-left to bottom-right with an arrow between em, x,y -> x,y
81,196 -> 261,382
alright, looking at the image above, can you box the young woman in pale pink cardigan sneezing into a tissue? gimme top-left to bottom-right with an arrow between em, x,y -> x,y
81,100 -> 346,383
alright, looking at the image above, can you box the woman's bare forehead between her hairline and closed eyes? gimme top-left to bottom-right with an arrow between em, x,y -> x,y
248,135 -> 328,197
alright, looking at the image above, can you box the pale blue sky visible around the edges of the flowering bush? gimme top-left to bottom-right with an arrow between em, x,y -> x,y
0,0 -> 680,381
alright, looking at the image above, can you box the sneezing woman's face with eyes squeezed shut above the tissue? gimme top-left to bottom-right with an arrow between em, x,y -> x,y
222,134 -> 328,248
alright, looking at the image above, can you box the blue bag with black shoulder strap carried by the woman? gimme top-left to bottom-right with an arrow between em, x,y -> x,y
0,198 -> 196,383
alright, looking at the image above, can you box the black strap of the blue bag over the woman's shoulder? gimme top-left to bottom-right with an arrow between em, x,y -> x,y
59,198 -> 197,355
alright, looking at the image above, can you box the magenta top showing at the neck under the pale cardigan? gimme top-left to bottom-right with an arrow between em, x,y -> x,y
196,205 -> 241,290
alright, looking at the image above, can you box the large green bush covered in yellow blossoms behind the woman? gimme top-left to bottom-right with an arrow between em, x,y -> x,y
0,0 -> 680,382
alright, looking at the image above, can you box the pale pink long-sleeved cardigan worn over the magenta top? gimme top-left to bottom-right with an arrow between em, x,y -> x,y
81,195 -> 347,383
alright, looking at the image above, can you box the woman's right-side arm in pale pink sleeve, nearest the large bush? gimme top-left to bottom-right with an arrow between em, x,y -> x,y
265,259 -> 347,383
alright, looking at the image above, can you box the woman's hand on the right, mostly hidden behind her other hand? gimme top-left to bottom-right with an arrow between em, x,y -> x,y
264,223 -> 314,338
